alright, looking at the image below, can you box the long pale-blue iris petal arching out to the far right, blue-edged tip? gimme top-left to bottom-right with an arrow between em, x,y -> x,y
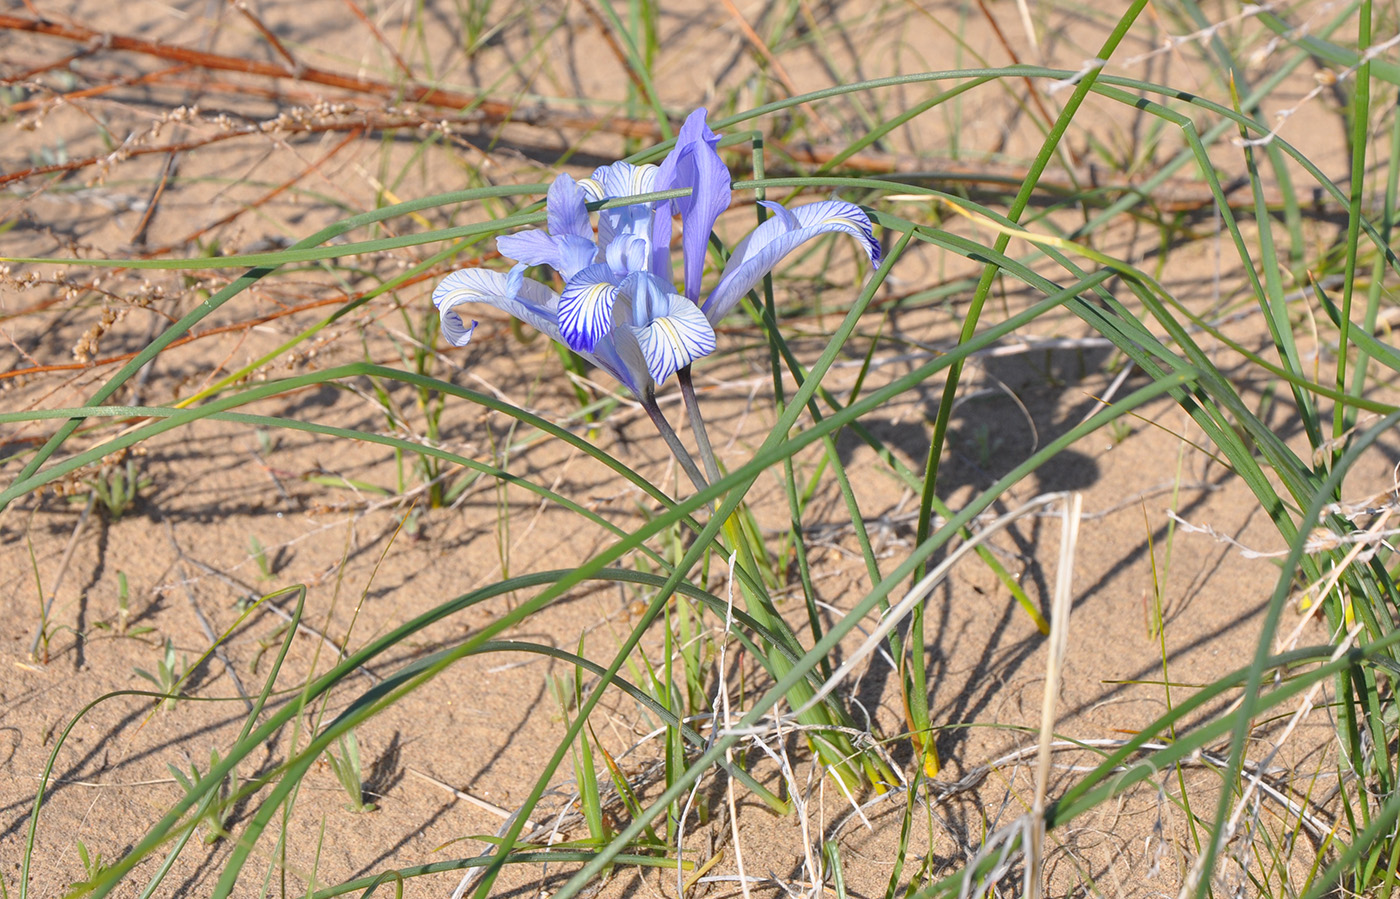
700,200 -> 879,322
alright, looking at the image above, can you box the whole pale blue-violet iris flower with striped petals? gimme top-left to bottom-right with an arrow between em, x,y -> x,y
433,108 -> 879,399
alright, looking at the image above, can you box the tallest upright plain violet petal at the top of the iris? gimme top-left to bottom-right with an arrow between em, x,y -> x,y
655,106 -> 732,301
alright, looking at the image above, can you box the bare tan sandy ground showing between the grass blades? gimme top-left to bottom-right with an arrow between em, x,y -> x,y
0,0 -> 1400,896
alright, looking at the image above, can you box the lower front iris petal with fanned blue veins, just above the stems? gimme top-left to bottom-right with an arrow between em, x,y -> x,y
613,272 -> 714,384
